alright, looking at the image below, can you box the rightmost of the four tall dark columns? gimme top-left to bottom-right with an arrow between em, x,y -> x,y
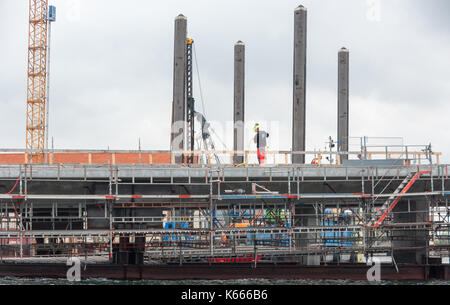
337,48 -> 350,160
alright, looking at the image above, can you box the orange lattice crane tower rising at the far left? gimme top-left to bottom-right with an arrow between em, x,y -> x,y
26,0 -> 48,163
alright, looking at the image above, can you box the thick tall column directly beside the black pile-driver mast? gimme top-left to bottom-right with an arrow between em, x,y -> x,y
170,14 -> 187,163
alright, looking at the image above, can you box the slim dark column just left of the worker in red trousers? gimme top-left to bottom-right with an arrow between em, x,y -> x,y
233,40 -> 245,164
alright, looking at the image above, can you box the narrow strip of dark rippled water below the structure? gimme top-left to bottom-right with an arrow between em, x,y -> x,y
0,277 -> 450,285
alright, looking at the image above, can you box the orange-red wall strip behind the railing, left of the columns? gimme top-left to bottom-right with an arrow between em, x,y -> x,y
0,153 -> 170,164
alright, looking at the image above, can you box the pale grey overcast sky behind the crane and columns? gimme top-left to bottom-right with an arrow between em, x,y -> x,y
0,0 -> 450,162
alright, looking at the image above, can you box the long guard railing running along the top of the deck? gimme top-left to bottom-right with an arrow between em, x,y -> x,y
0,145 -> 442,166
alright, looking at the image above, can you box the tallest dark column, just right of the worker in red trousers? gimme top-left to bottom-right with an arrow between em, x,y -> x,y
292,5 -> 307,164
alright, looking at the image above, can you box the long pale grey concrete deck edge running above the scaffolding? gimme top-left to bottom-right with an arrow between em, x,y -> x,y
0,164 -> 442,180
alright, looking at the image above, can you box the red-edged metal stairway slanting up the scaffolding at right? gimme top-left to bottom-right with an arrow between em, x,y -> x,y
369,171 -> 431,228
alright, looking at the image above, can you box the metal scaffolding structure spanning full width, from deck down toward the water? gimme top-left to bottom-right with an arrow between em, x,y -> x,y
0,150 -> 450,265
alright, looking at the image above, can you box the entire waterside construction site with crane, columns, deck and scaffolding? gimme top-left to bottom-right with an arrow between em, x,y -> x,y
0,0 -> 450,280
